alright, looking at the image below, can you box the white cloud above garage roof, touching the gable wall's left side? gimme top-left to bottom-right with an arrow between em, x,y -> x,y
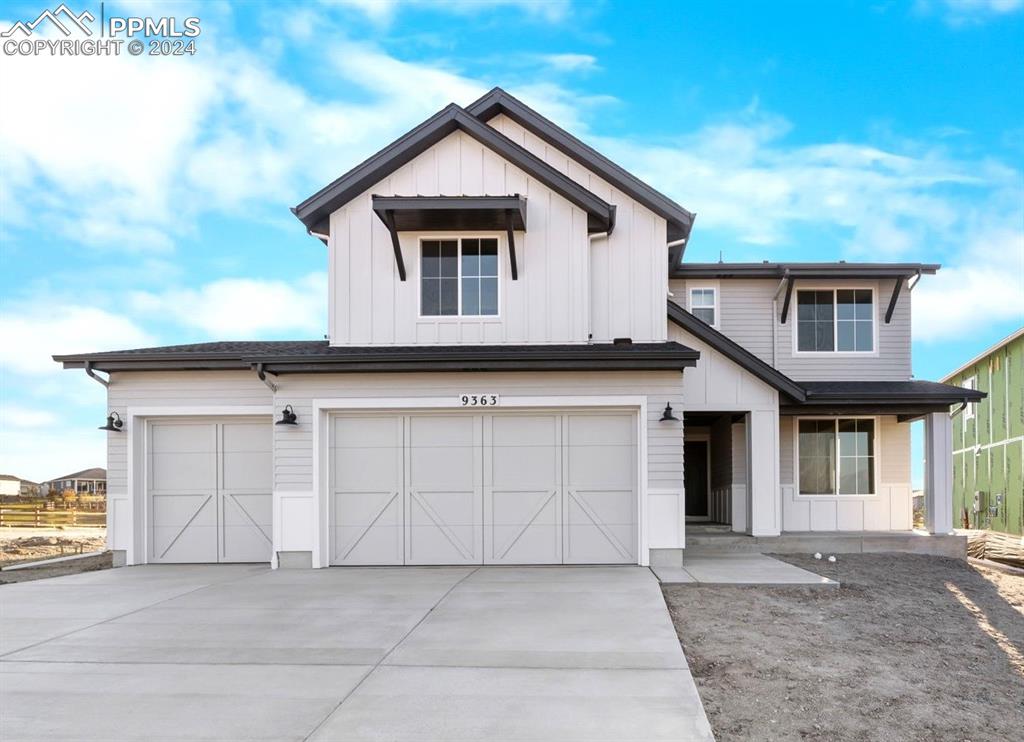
128,273 -> 327,340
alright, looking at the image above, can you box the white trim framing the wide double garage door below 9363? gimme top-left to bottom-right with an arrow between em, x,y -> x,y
312,394 -> 649,568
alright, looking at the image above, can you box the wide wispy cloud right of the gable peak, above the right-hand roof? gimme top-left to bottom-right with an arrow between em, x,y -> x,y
595,113 -> 1020,254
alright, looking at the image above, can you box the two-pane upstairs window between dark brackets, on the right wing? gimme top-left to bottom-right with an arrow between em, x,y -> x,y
797,289 -> 874,353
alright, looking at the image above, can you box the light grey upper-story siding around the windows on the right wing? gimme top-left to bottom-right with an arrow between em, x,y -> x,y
670,278 -> 910,381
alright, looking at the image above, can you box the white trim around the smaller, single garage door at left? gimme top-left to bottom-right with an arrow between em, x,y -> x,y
125,404 -> 273,565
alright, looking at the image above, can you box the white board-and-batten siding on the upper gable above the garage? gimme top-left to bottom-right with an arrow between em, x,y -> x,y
329,132 -> 668,345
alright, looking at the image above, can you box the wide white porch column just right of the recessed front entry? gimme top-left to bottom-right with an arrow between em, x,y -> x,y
746,409 -> 781,536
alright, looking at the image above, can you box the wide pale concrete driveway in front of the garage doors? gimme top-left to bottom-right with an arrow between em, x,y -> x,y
0,565 -> 711,741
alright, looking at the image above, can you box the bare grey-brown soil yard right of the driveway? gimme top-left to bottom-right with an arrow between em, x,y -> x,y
665,554 -> 1024,742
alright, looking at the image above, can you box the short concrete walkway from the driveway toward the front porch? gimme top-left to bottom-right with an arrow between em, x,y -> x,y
653,554 -> 839,587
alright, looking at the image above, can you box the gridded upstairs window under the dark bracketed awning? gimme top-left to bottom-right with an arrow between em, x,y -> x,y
420,237 -> 498,317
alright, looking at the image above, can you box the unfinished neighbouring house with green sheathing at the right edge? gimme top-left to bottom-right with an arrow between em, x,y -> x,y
942,328 -> 1024,536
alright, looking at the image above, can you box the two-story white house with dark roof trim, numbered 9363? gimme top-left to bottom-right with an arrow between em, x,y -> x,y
55,89 -> 979,567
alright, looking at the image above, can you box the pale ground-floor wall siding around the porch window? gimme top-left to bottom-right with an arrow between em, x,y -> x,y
779,416 -> 913,532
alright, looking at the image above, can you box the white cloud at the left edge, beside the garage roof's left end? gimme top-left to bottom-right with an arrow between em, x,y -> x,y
0,300 -> 154,372
